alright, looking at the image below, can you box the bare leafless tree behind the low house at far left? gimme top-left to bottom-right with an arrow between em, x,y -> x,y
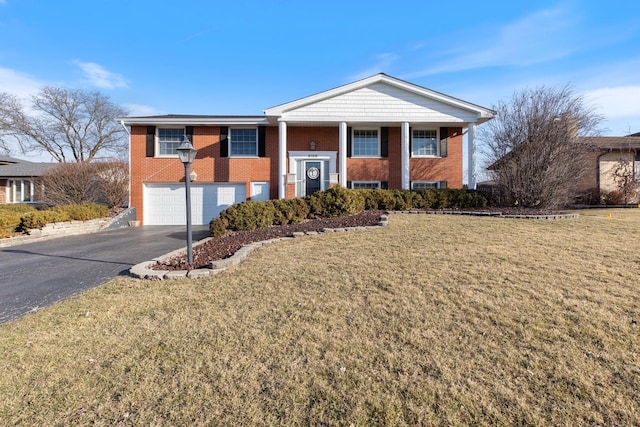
0,86 -> 127,163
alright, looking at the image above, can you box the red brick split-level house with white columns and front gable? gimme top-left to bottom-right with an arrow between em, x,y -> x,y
118,74 -> 495,225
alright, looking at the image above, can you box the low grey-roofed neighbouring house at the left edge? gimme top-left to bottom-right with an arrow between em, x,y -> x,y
0,156 -> 57,204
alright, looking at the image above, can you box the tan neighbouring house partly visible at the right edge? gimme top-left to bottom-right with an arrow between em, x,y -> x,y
578,133 -> 640,203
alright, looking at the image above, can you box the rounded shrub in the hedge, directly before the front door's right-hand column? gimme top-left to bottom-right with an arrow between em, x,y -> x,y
306,186 -> 365,218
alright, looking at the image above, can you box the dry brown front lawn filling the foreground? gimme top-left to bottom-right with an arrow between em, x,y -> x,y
0,209 -> 640,426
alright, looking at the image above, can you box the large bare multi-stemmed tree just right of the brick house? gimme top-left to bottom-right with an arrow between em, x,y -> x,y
479,85 -> 602,208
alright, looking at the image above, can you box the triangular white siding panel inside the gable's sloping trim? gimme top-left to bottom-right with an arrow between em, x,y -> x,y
282,82 -> 478,123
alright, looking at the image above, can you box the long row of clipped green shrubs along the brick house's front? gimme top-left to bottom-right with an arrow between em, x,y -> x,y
209,186 -> 493,237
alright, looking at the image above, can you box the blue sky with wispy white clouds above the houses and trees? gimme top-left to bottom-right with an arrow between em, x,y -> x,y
0,0 -> 640,161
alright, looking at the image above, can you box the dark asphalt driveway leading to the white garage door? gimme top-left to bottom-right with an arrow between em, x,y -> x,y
0,226 -> 209,323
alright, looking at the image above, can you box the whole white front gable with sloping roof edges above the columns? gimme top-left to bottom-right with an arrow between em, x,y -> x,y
264,73 -> 495,124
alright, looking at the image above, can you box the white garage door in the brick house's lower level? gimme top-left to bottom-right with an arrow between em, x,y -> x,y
144,183 -> 246,225
